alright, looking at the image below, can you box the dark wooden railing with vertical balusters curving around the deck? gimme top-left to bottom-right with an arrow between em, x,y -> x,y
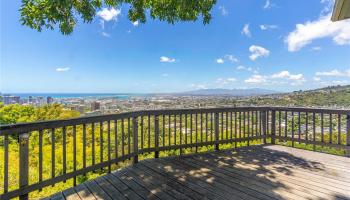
0,107 -> 350,199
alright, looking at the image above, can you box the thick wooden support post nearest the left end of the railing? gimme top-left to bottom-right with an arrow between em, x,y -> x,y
19,133 -> 29,200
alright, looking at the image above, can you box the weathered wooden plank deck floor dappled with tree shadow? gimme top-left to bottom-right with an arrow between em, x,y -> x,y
47,145 -> 350,200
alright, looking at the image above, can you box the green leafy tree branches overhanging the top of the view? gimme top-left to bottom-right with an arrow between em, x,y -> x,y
20,0 -> 216,34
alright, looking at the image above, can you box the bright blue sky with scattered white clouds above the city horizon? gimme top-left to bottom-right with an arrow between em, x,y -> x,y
0,0 -> 350,93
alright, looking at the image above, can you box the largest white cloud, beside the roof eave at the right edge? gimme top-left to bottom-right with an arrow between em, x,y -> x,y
285,13 -> 350,52
